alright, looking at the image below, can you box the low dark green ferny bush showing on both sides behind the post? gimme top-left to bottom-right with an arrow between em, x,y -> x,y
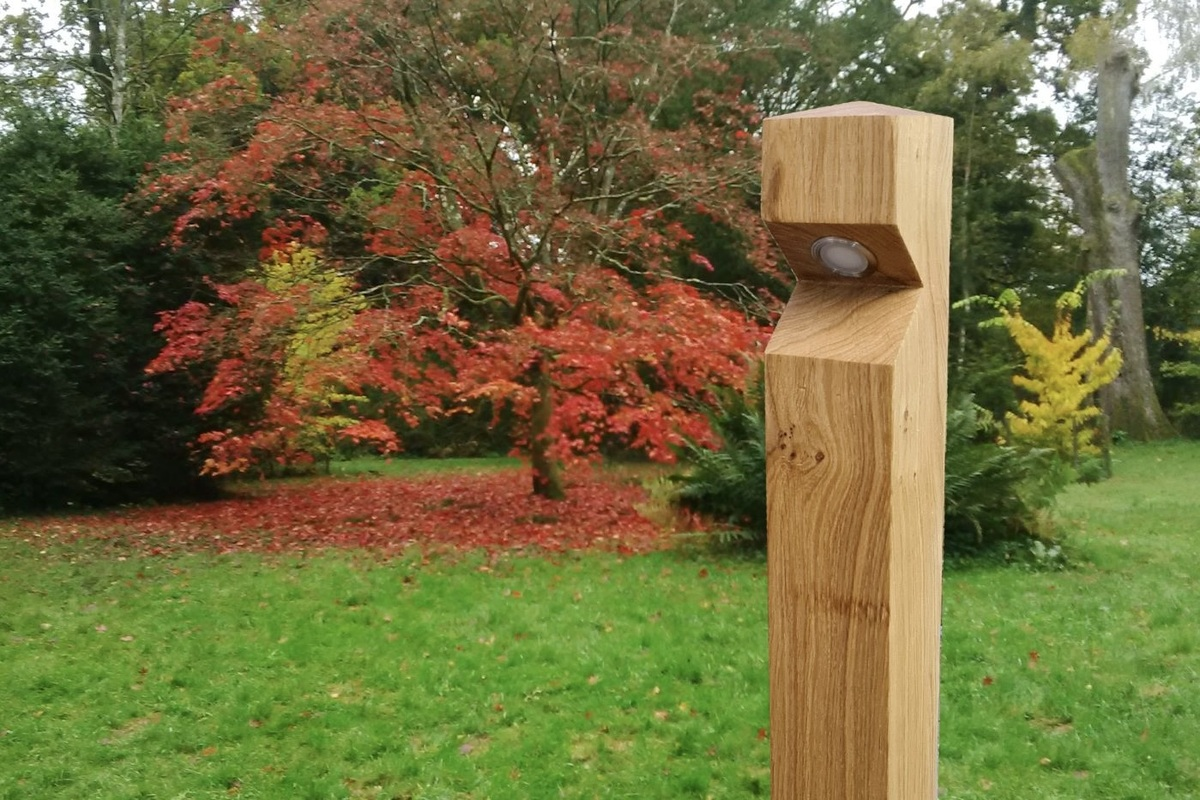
672,374 -> 1073,557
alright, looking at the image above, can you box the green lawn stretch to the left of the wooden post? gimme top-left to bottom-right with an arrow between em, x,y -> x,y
0,545 -> 768,799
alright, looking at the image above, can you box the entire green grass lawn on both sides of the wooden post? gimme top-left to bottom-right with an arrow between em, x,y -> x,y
0,444 -> 1200,800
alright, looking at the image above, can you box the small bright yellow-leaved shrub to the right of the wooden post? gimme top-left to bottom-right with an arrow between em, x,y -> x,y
979,280 -> 1121,459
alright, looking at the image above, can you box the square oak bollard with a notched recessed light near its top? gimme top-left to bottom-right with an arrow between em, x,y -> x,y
762,103 -> 953,800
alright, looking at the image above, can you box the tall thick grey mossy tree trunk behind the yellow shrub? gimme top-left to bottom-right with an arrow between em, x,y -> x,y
1054,37 -> 1174,439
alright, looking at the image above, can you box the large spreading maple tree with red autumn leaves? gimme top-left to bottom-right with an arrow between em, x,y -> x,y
143,0 -> 780,497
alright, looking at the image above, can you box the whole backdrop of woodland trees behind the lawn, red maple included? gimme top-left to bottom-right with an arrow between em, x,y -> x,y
0,0 -> 1200,522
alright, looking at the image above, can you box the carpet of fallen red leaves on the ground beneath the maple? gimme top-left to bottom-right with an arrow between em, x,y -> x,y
14,471 -> 664,554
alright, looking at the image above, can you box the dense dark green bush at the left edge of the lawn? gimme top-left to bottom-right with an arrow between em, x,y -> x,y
0,112 -> 209,513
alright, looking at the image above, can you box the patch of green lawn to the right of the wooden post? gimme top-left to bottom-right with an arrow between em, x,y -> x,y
941,443 -> 1200,800
